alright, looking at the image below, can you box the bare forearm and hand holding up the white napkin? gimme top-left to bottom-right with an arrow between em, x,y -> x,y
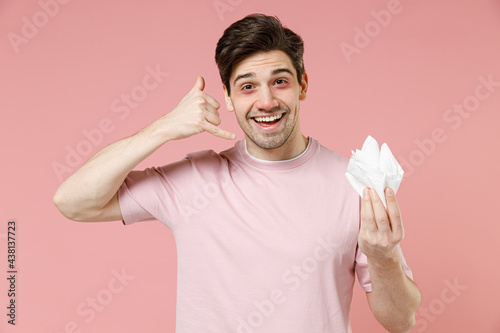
358,189 -> 421,333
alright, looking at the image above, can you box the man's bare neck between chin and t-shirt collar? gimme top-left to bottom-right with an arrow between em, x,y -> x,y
245,132 -> 309,161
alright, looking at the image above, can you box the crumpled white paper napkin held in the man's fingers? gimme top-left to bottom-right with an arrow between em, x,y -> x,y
345,135 -> 404,209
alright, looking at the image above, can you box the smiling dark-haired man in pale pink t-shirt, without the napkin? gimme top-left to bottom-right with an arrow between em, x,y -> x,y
54,14 -> 420,333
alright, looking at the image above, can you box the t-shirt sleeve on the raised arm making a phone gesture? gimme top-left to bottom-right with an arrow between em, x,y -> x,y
118,156 -> 192,229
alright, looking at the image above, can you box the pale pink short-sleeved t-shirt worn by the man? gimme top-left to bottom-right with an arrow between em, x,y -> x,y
118,138 -> 412,333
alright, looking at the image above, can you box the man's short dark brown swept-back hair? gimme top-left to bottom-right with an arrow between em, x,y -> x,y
215,14 -> 305,95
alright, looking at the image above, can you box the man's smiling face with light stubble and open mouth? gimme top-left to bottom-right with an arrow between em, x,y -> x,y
223,50 -> 307,149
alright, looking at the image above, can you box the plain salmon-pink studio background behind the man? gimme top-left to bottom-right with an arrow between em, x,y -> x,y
0,0 -> 500,333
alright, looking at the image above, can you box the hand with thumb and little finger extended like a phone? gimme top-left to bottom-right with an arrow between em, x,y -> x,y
161,76 -> 236,140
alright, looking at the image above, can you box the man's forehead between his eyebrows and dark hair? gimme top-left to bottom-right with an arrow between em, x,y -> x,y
230,50 -> 295,83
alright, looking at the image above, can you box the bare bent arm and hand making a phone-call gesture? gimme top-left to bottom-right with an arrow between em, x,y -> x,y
54,77 -> 234,222
